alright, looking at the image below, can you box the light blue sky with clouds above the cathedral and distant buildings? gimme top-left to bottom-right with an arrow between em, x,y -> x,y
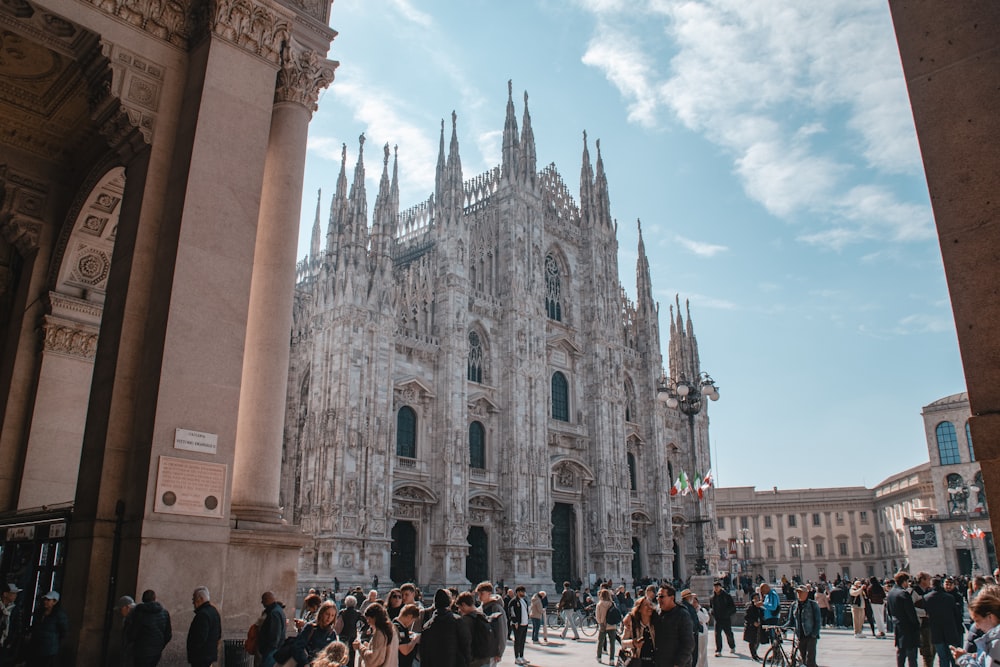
299,0 -> 965,488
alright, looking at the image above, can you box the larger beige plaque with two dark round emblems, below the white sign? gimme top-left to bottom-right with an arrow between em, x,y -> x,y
153,456 -> 227,518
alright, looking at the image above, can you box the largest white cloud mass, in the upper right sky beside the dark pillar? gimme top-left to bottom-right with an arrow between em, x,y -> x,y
578,0 -> 933,249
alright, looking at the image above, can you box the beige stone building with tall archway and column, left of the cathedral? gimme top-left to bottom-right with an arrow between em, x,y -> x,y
0,0 -> 337,665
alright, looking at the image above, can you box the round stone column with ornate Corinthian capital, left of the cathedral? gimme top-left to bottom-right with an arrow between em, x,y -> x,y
232,46 -> 337,523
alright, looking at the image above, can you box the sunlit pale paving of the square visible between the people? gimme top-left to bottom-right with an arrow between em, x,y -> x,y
500,628 -> 896,667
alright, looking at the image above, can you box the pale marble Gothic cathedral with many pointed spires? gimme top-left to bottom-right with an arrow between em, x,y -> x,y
281,86 -> 718,587
